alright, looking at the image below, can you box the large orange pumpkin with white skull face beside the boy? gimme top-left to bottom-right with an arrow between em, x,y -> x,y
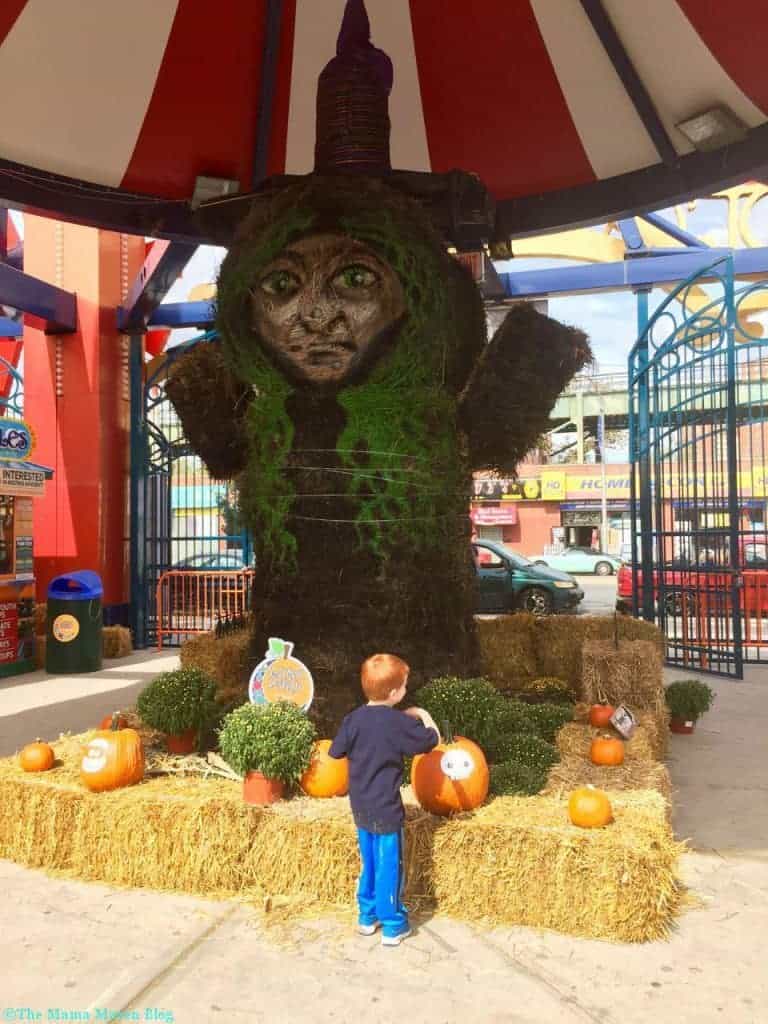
411,736 -> 488,814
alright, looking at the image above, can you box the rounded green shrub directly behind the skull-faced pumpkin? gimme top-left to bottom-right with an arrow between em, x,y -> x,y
414,676 -> 508,751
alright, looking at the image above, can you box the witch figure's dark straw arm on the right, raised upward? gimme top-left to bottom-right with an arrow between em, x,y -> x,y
459,302 -> 592,473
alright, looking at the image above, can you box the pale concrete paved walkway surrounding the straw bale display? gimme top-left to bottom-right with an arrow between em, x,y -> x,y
0,654 -> 768,1024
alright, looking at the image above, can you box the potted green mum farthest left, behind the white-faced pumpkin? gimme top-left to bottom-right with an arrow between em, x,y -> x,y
136,668 -> 218,754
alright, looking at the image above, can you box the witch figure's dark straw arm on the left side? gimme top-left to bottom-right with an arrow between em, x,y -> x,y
166,343 -> 253,480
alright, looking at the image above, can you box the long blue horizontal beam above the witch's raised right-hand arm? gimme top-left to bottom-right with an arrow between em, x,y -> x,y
499,247 -> 768,299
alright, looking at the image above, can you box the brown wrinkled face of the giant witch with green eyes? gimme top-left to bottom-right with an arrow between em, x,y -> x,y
251,233 -> 406,386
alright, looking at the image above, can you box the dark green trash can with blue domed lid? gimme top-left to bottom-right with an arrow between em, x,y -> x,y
45,569 -> 103,675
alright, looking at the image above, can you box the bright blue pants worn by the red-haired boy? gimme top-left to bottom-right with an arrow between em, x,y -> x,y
357,828 -> 408,937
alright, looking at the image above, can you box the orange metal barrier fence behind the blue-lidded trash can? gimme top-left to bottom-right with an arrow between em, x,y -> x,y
157,569 -> 254,648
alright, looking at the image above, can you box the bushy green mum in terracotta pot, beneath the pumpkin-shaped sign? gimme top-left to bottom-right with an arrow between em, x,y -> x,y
219,701 -> 315,804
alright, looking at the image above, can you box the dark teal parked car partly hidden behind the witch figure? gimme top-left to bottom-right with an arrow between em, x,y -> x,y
472,541 -> 584,615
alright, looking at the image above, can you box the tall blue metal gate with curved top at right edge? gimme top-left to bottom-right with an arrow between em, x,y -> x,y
629,255 -> 768,678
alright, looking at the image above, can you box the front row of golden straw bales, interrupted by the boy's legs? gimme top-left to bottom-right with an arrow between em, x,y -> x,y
0,734 -> 681,942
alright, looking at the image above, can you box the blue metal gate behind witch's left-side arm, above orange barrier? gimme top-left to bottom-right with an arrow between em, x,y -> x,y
131,332 -> 252,647
